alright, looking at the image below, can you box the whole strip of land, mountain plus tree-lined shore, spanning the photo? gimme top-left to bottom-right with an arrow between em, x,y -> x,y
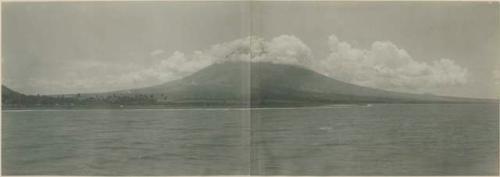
2,62 -> 497,107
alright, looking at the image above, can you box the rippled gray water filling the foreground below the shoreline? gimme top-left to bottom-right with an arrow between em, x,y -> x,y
2,104 -> 499,175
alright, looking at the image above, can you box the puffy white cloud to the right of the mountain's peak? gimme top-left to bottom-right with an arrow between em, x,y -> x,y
312,35 -> 467,92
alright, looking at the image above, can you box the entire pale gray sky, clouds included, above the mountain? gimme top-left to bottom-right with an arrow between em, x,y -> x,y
2,2 -> 500,98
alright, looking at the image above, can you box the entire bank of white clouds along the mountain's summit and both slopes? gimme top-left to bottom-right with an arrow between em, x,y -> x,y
16,35 -> 468,93
